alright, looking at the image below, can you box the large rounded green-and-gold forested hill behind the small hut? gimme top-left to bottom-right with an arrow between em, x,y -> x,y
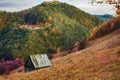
0,1 -> 102,59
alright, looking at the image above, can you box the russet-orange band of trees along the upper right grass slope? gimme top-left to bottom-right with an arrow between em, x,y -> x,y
91,16 -> 120,39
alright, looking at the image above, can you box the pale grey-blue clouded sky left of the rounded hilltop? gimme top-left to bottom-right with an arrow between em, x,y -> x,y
0,0 -> 45,12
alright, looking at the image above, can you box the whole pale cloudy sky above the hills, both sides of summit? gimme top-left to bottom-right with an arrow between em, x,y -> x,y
0,0 -> 115,15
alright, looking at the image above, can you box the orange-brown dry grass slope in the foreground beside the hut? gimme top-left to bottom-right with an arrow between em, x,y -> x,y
0,28 -> 120,80
